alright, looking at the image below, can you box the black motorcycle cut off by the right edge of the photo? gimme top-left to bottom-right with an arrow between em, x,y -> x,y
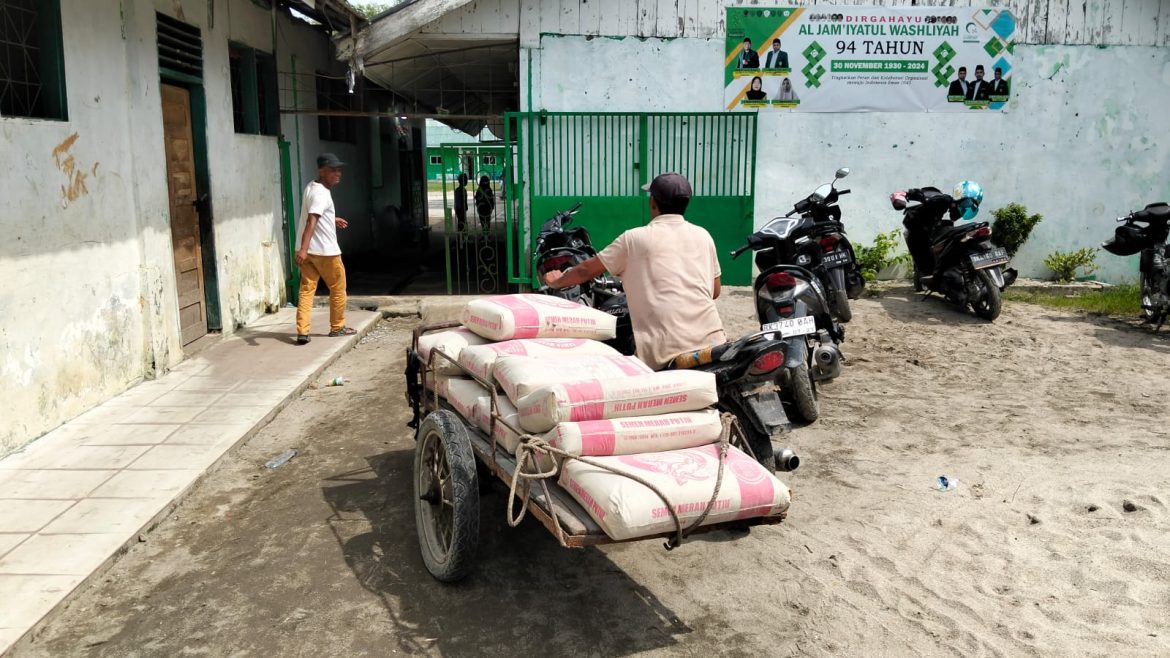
1101,196 -> 1170,331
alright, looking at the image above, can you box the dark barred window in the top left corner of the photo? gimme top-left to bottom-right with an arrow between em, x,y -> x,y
0,0 -> 69,121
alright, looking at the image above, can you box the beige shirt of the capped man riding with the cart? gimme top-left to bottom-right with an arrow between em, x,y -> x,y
598,214 -> 727,370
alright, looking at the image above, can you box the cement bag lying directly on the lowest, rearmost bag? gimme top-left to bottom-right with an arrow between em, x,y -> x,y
543,410 -> 723,457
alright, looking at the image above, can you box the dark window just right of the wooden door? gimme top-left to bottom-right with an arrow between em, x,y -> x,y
228,43 -> 281,135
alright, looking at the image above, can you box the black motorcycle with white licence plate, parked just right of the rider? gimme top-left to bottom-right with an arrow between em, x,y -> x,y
731,229 -> 845,423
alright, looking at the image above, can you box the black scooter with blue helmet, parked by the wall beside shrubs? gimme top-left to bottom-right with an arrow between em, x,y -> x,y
890,180 -> 1017,322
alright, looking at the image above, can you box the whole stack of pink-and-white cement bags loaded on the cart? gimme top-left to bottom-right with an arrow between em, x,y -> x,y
419,295 -> 789,540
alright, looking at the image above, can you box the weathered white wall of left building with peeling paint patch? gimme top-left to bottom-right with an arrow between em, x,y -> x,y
0,0 -> 353,455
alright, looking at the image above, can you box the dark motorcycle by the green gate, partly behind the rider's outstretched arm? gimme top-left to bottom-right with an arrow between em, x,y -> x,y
532,201 -> 635,356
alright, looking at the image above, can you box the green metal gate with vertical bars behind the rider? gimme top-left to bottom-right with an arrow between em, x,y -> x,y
504,112 -> 756,286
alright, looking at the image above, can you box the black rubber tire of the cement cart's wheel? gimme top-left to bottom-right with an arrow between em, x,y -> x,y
413,410 -> 480,583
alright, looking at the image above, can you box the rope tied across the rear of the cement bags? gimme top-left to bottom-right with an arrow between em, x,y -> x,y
508,412 -> 739,550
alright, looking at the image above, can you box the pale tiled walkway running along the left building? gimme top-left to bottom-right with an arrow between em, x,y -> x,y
0,308 -> 380,654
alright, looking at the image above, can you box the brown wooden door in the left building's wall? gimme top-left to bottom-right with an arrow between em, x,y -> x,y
161,84 -> 207,345
